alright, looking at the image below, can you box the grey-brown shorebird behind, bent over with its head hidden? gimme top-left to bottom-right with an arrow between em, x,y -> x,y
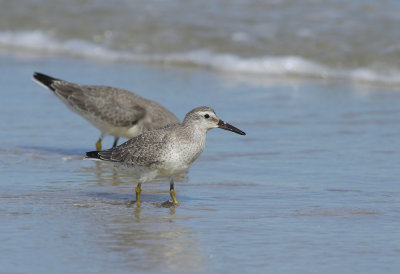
33,72 -> 179,150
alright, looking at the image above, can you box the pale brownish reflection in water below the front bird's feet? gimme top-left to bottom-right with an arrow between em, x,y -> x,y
100,208 -> 205,272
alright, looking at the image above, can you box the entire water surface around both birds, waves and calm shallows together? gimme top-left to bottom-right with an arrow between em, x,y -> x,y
0,0 -> 400,273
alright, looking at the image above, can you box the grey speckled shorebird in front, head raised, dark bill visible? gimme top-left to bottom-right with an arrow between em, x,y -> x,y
86,107 -> 246,205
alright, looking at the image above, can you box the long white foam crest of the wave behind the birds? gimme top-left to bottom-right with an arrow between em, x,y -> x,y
0,31 -> 400,85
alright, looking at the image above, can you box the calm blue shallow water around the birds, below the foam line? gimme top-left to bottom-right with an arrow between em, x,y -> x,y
0,56 -> 400,273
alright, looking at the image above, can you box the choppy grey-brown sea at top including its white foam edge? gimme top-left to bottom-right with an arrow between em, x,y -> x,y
0,0 -> 400,85
